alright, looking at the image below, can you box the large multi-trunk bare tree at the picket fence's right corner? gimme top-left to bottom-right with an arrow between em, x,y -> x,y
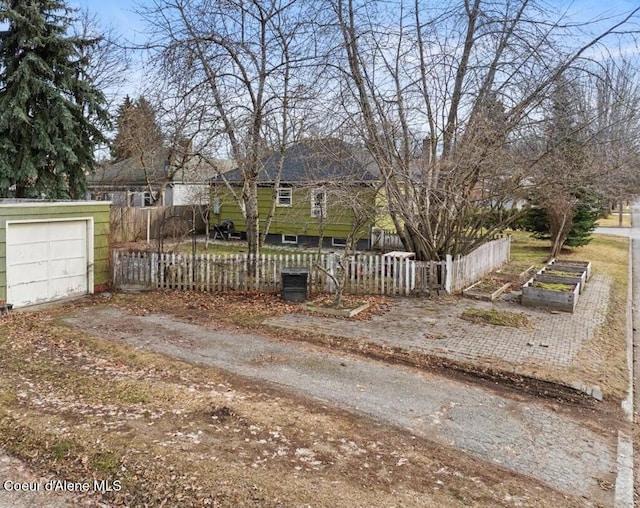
327,0 -> 640,259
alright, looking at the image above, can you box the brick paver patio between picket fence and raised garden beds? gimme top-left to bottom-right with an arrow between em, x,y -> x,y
265,274 -> 611,383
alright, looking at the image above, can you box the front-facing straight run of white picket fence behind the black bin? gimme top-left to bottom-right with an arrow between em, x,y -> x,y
113,251 -> 422,295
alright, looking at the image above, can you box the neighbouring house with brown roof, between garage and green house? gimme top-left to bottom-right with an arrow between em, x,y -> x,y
87,145 -> 233,207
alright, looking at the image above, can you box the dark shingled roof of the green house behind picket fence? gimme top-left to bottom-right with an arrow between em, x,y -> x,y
225,138 -> 379,183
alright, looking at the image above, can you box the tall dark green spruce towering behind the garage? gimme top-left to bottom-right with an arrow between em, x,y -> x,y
0,0 -> 108,199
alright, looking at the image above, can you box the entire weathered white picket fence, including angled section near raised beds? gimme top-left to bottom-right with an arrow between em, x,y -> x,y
113,237 -> 510,295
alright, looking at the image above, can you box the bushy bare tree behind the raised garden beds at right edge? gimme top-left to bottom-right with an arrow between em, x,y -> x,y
528,60 -> 640,257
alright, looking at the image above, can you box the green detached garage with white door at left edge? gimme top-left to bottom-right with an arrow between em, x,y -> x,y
0,201 -> 110,307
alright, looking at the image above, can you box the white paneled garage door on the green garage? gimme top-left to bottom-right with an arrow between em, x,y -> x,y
7,220 -> 88,307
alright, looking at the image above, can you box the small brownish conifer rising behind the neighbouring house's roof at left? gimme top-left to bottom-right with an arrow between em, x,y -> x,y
111,96 -> 164,162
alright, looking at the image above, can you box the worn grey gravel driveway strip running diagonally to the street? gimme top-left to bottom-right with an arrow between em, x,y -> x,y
67,307 -> 616,506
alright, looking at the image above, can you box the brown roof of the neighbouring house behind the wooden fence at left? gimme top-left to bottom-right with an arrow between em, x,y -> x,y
87,148 -> 235,187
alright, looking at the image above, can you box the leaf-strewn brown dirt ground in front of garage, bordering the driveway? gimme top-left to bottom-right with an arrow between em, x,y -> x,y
0,293 -> 613,507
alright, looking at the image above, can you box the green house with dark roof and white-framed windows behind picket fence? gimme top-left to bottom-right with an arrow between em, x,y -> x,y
211,138 -> 379,249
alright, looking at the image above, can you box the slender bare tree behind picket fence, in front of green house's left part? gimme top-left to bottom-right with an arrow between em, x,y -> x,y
143,0 -> 313,255
